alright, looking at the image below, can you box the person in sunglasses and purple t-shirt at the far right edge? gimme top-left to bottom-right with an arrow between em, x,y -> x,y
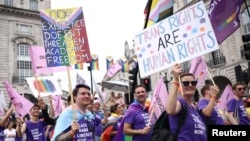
227,82 -> 250,125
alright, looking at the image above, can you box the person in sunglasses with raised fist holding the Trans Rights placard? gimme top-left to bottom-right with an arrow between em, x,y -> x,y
166,64 -> 207,141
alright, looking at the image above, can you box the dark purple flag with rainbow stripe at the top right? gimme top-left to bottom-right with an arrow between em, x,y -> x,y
209,0 -> 243,43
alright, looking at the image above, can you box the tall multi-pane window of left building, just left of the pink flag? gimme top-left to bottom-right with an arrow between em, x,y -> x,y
16,43 -> 32,82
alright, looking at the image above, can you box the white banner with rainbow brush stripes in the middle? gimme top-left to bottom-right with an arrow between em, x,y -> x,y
26,76 -> 63,97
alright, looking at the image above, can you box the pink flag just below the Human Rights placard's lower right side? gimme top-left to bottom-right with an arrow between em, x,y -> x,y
189,56 -> 208,87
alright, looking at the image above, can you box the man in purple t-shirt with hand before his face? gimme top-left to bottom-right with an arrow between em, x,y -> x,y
198,84 -> 225,125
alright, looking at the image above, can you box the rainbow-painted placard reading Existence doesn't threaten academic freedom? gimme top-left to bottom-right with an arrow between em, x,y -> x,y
40,7 -> 91,67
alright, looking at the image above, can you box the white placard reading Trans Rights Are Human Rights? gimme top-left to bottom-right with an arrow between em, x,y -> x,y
134,1 -> 219,78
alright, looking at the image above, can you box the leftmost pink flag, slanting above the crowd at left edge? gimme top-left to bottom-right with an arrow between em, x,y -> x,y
4,81 -> 34,118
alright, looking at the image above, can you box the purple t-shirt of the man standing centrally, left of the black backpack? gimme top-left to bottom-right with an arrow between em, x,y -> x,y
124,109 -> 152,141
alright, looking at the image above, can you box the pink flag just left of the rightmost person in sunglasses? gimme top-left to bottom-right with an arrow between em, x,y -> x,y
216,84 -> 234,111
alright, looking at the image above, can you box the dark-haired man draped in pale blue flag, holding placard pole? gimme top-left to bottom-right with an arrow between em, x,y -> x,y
52,84 -> 98,141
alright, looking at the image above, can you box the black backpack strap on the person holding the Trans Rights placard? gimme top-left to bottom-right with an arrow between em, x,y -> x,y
175,104 -> 188,137
